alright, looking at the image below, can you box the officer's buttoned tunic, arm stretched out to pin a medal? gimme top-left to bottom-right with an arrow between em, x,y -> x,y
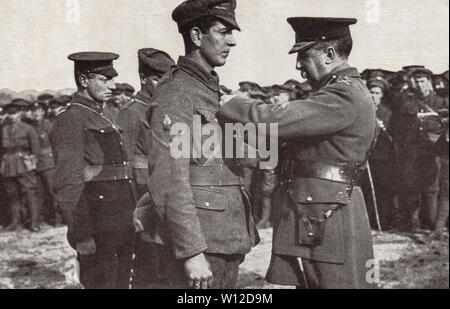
218,65 -> 376,267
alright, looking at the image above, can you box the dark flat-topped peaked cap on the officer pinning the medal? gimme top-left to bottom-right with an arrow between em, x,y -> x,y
287,17 -> 358,54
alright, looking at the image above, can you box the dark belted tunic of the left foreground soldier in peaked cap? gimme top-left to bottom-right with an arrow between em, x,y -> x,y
50,94 -> 135,247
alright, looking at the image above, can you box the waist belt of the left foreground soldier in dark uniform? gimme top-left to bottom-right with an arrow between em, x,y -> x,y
83,162 -> 133,182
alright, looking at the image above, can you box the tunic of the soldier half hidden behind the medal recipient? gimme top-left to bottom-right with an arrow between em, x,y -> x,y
118,93 -> 150,185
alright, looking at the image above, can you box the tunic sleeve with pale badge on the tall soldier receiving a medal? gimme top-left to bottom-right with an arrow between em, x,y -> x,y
149,83 -> 207,259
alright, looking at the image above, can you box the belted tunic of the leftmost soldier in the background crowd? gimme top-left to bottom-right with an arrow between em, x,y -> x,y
0,121 -> 41,177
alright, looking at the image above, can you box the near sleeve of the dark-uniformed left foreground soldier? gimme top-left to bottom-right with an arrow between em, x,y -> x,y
51,111 -> 94,244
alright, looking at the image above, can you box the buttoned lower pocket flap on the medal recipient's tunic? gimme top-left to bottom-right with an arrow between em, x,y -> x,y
192,187 -> 228,211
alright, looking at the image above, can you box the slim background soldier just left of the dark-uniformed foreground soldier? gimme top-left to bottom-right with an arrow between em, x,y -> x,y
31,101 -> 62,226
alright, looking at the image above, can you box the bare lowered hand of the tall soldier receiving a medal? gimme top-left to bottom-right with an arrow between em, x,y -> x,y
184,253 -> 213,289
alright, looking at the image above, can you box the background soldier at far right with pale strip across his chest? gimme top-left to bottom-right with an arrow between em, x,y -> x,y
394,68 -> 448,231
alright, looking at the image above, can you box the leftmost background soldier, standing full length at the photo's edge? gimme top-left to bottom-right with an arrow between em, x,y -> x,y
0,99 -> 40,232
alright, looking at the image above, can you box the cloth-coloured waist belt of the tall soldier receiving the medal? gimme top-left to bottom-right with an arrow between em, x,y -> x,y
189,165 -> 243,187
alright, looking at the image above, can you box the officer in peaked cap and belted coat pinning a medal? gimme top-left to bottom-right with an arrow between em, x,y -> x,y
218,17 -> 376,288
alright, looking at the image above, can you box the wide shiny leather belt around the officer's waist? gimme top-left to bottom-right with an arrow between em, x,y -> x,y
283,160 -> 362,186
